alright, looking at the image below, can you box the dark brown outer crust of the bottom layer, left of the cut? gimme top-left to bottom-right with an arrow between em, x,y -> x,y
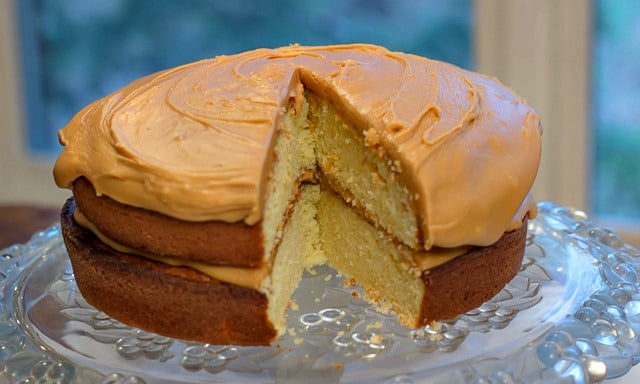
61,199 -> 276,345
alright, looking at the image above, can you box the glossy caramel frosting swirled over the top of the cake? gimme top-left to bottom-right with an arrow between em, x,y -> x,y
54,44 -> 541,249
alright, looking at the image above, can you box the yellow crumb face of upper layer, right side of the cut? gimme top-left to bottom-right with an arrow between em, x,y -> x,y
307,93 -> 420,248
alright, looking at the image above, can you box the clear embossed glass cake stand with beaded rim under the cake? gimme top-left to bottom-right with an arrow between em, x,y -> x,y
0,202 -> 640,384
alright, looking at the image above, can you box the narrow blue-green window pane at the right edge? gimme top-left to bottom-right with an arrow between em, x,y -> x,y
591,0 -> 640,217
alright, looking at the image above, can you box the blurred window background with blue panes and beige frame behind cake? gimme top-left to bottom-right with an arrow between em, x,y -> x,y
0,0 -> 640,244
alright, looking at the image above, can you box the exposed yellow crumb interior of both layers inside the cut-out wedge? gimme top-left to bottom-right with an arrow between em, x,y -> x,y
261,90 -> 458,331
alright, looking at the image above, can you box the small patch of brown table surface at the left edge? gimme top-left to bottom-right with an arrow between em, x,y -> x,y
0,205 -> 61,249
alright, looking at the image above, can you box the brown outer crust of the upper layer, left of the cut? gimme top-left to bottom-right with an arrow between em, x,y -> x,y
73,177 -> 264,267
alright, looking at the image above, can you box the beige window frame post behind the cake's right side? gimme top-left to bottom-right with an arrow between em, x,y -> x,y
473,0 -> 640,246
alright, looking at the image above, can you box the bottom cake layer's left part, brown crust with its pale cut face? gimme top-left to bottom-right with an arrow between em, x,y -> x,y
61,185 -> 323,345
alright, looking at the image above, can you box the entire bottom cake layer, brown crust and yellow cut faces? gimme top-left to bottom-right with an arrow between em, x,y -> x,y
61,191 -> 526,345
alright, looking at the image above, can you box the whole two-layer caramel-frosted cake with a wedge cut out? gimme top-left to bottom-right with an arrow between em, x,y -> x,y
54,44 -> 541,345
